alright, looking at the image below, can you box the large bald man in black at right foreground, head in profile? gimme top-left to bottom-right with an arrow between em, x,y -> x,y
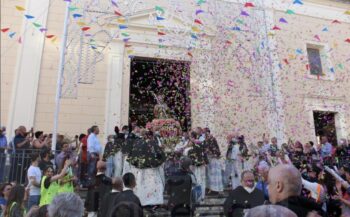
268,164 -> 322,217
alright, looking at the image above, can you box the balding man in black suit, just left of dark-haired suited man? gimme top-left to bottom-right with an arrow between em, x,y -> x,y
99,177 -> 123,217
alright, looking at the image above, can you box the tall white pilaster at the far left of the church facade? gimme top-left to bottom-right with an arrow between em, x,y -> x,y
7,0 -> 50,138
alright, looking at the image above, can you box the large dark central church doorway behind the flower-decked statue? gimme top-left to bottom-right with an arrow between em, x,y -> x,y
129,57 -> 191,130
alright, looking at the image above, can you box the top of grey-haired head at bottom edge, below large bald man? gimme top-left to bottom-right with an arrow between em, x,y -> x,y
245,205 -> 297,217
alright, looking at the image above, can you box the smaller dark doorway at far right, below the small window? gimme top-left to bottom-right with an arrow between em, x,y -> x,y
314,111 -> 338,144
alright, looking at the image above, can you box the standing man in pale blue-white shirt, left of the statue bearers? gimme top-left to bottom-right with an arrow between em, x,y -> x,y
87,126 -> 102,178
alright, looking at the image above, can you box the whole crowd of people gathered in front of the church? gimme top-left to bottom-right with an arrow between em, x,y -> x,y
0,125 -> 350,217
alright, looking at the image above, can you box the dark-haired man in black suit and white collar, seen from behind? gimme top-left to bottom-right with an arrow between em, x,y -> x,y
114,173 -> 141,208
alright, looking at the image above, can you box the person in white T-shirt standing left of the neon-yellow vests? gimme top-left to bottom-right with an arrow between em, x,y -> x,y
27,153 -> 41,210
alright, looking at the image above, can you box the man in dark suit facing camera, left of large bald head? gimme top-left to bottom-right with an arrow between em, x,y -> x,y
224,170 -> 265,217
